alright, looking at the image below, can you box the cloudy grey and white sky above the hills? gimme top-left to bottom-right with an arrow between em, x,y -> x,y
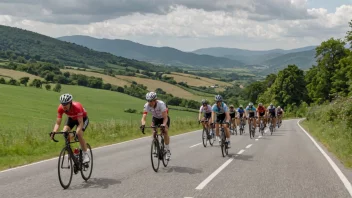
0,0 -> 352,51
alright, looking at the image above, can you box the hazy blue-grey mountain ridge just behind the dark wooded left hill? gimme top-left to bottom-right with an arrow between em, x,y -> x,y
58,35 -> 245,67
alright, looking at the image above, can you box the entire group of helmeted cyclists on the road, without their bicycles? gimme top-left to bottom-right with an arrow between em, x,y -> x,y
51,92 -> 284,163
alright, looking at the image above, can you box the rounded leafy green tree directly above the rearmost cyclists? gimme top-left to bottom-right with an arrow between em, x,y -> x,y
271,65 -> 307,107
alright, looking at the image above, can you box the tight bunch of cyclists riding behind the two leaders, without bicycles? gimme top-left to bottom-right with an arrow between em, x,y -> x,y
198,95 -> 284,148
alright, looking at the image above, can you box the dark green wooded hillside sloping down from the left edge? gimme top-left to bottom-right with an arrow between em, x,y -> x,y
0,25 -> 170,71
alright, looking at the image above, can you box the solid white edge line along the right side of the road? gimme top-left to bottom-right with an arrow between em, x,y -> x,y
297,119 -> 352,197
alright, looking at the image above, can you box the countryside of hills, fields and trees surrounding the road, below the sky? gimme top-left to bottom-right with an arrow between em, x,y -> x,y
0,0 -> 352,196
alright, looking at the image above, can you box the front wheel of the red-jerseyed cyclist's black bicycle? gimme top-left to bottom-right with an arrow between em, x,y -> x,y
58,147 -> 73,189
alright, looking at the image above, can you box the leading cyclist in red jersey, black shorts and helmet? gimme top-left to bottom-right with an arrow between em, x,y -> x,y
51,93 -> 90,163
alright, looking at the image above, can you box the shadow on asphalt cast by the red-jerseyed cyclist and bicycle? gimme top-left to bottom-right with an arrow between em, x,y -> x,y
70,178 -> 121,190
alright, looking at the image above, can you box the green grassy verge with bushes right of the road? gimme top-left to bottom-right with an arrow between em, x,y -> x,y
301,98 -> 352,168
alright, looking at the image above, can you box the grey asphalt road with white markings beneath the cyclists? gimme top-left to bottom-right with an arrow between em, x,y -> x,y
0,120 -> 352,198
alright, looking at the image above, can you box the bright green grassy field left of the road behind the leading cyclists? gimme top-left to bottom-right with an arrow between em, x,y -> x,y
0,84 -> 199,169
